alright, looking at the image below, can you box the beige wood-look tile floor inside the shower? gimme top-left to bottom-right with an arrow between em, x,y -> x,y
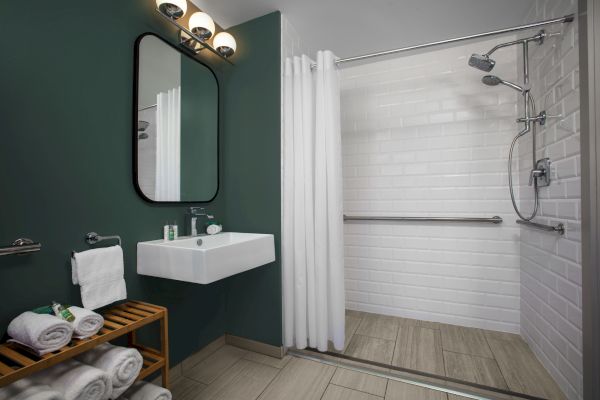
334,310 -> 564,400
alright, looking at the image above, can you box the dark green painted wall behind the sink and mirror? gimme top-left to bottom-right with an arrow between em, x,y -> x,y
0,0 -> 281,362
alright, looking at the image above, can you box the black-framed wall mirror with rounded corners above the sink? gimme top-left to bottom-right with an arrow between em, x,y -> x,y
133,33 -> 219,203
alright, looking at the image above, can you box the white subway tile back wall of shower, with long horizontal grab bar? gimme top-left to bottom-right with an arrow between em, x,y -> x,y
341,36 -> 520,332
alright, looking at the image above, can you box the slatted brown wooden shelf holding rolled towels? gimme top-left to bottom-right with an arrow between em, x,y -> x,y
0,300 -> 169,388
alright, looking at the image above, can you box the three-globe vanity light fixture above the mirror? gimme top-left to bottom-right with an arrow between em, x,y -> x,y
156,0 -> 236,64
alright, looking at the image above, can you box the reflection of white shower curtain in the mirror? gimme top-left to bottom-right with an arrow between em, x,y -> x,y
154,87 -> 181,201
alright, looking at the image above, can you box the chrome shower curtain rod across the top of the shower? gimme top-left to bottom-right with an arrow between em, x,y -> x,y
310,14 -> 575,69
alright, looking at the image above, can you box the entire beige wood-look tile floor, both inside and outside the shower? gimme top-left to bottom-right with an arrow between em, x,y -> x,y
172,311 -> 564,400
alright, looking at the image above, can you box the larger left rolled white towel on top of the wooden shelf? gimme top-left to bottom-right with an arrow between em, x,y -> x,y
6,311 -> 73,355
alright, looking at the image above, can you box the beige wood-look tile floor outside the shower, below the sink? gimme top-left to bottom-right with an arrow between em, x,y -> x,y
171,345 -> 474,400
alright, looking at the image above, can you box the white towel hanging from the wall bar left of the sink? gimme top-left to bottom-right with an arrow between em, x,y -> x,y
71,246 -> 127,310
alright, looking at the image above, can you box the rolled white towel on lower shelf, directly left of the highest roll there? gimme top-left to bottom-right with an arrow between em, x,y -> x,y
31,360 -> 112,400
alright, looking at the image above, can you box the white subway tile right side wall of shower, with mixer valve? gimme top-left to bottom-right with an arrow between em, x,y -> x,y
519,0 -> 583,399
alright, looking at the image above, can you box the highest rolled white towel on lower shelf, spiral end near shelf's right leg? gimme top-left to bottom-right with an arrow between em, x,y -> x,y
77,343 -> 144,399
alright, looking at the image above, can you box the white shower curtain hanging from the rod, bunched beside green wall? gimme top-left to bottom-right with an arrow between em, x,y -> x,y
282,51 -> 345,351
